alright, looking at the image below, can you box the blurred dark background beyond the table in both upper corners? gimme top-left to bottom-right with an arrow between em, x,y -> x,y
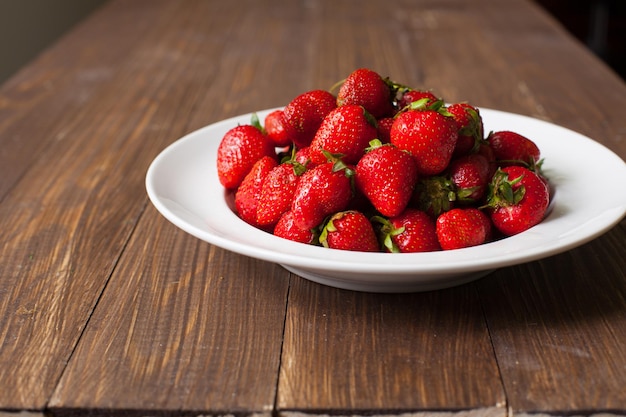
0,0 -> 626,84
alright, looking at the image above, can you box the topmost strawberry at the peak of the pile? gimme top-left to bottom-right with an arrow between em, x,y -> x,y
337,68 -> 394,119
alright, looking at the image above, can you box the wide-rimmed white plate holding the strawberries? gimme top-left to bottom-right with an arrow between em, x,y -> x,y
146,109 -> 626,292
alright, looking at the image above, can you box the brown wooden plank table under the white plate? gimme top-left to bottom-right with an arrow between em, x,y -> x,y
0,0 -> 626,416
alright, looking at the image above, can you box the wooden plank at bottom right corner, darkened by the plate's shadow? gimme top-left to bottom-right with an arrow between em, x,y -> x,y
478,221 -> 626,414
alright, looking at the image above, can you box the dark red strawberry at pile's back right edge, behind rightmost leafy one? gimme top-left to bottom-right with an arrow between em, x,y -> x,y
487,130 -> 541,169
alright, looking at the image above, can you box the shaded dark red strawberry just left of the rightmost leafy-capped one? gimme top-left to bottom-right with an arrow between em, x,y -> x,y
449,154 -> 491,203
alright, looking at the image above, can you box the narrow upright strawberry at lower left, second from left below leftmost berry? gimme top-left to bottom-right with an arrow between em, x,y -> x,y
256,157 -> 306,226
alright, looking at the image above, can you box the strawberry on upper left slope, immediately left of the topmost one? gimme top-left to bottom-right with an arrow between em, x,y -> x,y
283,90 -> 337,148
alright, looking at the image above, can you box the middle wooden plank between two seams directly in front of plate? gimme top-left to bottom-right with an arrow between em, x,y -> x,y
277,279 -> 506,415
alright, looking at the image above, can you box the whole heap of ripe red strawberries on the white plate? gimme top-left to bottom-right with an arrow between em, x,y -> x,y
217,68 -> 550,252
